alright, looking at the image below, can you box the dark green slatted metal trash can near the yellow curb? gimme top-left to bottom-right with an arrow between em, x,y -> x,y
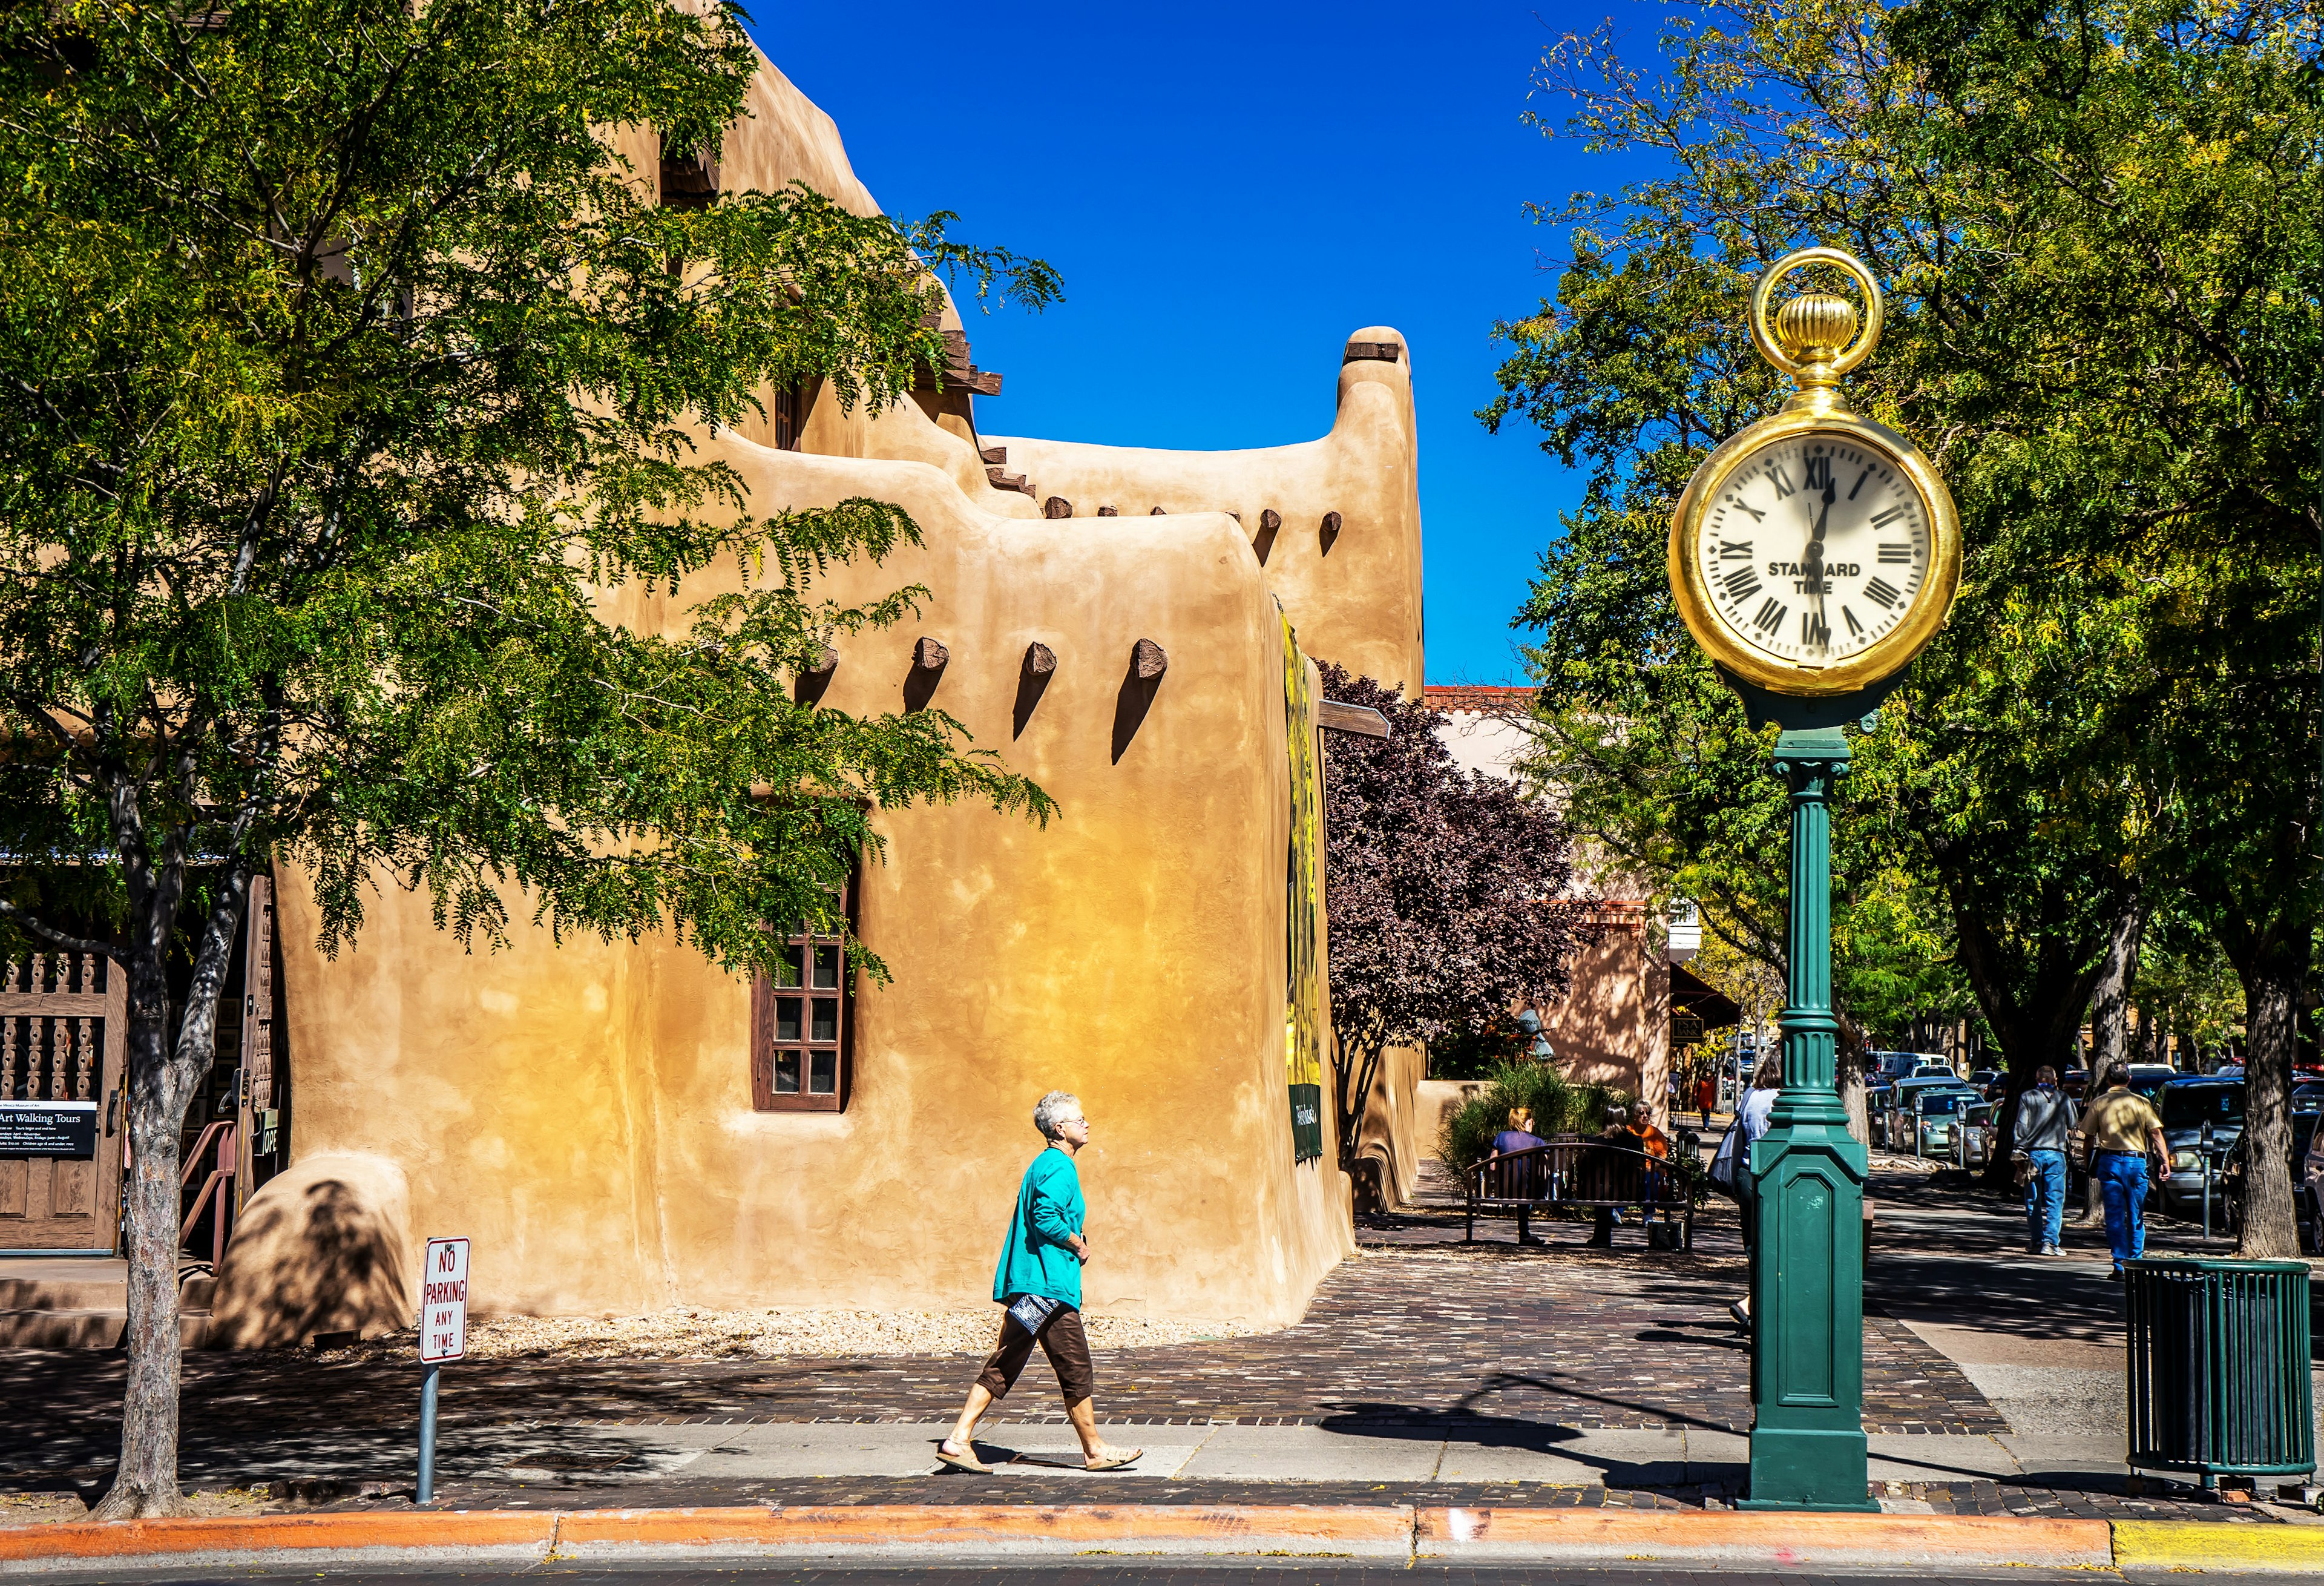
2122,1258 -> 2317,1486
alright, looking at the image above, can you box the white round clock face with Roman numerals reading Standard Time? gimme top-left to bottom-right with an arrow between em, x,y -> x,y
1694,430 -> 1931,668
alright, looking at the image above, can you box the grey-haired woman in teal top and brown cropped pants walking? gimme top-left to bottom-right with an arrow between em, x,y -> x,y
937,1091 -> 1146,1475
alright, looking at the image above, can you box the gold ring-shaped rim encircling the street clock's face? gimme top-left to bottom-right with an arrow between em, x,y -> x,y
1671,390 -> 1961,700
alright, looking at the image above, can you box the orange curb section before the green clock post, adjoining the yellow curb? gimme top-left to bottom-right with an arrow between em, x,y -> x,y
1416,1509 -> 2113,1565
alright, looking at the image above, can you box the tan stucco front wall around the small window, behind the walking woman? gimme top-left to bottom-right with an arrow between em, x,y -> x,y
221,442 -> 1353,1321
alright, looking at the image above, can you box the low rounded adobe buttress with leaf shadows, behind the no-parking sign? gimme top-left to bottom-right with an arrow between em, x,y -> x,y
211,1156 -> 414,1349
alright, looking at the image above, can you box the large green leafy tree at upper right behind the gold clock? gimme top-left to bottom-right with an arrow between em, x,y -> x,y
1488,0 -> 2324,1219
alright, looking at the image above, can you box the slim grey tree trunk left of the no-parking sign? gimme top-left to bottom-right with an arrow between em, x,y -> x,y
91,949 -> 191,1521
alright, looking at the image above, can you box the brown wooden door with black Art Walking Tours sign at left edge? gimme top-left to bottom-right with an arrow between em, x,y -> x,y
0,953 -> 130,1255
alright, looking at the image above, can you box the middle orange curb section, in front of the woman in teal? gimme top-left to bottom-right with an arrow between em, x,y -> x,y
556,1505 -> 1413,1558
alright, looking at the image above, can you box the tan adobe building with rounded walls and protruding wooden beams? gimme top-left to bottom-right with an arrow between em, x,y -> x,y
181,46 -> 1425,1344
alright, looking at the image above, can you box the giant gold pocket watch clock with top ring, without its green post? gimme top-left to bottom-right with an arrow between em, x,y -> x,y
1671,249 -> 1961,697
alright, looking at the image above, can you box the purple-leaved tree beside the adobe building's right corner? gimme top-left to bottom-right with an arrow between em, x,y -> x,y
1322,663 -> 1590,1172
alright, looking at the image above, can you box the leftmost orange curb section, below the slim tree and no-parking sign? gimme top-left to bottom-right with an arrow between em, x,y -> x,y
0,1509 -> 558,1563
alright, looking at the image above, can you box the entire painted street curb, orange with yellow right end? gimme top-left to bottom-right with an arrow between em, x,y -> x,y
0,1505 -> 2324,1577
